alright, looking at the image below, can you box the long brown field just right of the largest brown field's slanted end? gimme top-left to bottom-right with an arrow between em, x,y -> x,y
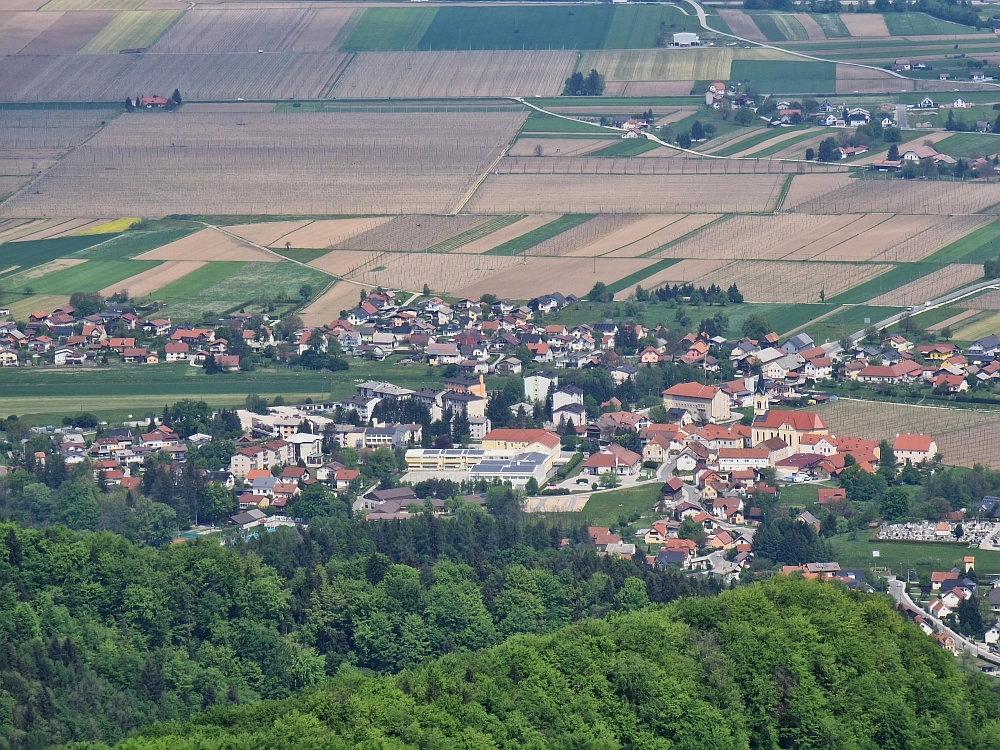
466,173 -> 782,214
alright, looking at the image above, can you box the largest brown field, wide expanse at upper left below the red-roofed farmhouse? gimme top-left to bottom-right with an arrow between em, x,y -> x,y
0,111 -> 528,217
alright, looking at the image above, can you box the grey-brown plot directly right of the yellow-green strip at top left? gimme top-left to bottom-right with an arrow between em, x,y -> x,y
150,6 -> 314,54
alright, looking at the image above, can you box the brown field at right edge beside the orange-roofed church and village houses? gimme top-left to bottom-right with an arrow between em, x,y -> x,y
815,398 -> 1000,467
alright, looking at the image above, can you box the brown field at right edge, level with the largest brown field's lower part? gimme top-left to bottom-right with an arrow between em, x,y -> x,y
784,180 -> 1000,215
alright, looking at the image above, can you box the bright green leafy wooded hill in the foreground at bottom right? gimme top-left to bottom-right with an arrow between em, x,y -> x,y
79,579 -> 1000,750
